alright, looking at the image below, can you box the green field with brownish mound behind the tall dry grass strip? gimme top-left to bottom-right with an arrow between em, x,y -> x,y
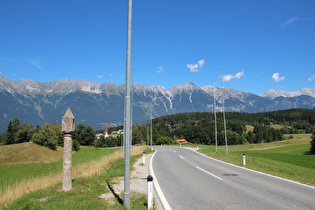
0,142 -> 114,191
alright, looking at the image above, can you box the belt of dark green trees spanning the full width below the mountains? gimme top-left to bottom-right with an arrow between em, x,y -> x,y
0,109 -> 315,149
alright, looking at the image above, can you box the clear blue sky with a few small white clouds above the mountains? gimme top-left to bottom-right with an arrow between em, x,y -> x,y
0,0 -> 315,95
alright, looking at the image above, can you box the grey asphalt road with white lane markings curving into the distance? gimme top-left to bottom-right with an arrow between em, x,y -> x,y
152,147 -> 315,210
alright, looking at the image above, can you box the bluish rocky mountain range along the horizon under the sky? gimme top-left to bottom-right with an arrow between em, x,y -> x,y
0,76 -> 315,133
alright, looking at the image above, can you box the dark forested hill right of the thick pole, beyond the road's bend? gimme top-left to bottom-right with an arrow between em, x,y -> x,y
145,109 -> 315,145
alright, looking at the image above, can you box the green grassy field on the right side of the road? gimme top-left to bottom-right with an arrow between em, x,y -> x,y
199,134 -> 315,185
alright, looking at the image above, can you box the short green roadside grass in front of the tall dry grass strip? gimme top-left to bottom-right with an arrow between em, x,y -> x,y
3,149 -> 151,209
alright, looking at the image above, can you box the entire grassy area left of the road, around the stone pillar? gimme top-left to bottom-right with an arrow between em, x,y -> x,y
0,143 -> 150,209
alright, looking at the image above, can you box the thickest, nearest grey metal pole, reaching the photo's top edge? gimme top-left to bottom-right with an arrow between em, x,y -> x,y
124,0 -> 132,209
